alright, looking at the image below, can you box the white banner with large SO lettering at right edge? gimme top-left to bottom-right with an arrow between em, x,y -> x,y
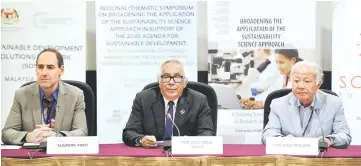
332,0 -> 361,145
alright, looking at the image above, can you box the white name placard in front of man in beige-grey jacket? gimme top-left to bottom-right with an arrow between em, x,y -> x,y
46,137 -> 99,154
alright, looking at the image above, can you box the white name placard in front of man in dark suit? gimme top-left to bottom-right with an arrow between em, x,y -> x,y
172,136 -> 223,154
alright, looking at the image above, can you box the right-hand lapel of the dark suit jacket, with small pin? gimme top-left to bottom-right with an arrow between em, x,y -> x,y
173,92 -> 189,136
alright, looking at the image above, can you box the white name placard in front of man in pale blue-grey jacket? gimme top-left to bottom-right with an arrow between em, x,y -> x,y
266,137 -> 318,156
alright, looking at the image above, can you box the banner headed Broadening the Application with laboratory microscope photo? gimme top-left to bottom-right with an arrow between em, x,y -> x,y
207,0 -> 316,144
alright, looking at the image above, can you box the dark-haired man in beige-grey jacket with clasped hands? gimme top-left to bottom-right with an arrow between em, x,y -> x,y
2,49 -> 88,144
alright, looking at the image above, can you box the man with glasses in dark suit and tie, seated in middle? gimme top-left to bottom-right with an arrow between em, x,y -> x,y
123,60 -> 216,147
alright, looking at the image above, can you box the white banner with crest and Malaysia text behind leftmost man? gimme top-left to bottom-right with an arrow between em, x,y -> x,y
1,0 -> 86,139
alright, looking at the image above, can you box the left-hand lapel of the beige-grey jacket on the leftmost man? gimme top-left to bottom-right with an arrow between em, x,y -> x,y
29,83 -> 42,128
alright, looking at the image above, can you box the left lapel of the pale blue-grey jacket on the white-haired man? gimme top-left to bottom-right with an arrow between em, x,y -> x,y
288,95 -> 303,136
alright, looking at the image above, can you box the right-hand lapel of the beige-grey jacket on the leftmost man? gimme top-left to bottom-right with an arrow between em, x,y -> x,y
55,82 -> 67,131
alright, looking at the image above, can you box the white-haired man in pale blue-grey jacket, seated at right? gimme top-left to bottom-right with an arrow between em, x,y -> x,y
262,61 -> 352,147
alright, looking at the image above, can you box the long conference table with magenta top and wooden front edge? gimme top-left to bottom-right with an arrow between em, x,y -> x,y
1,144 -> 361,166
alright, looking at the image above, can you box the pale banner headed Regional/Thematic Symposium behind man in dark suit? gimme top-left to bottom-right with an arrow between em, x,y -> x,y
96,1 -> 197,143
